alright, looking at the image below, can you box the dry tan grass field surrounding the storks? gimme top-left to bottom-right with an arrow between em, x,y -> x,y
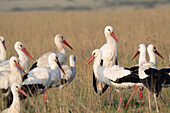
0,8 -> 170,113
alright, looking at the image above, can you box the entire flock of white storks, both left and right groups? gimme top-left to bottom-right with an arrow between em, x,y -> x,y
0,26 -> 170,113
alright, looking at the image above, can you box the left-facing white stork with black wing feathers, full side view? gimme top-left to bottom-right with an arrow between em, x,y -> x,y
86,49 -> 143,110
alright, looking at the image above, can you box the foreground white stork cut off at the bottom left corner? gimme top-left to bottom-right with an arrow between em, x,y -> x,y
2,82 -> 27,113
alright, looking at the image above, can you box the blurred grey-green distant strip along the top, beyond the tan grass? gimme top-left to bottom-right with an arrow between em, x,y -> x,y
0,0 -> 170,12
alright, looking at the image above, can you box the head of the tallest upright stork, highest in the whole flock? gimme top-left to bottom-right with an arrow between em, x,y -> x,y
104,26 -> 119,42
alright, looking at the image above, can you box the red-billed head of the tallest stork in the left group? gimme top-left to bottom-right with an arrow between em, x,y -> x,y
54,34 -> 73,50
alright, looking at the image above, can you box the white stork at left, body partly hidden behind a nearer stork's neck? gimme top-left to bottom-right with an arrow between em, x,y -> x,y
0,41 -> 33,72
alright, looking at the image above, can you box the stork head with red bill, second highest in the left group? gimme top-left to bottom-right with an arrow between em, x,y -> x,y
14,41 -> 34,60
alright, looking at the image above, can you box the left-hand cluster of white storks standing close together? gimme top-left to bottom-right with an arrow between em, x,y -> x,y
0,34 -> 76,113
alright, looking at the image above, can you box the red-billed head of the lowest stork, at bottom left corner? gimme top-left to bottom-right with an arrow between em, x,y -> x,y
11,82 -> 27,97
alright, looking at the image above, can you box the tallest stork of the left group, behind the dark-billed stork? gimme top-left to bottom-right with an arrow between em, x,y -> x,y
30,34 -> 73,70
